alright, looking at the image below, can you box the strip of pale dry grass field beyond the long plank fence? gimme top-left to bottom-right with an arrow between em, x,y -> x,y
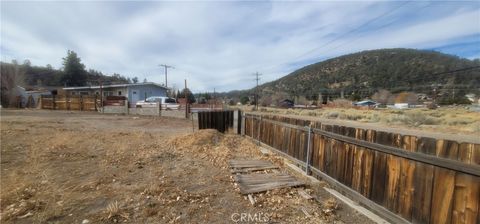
231,107 -> 480,134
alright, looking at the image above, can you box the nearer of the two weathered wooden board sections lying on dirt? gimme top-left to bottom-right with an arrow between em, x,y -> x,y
235,173 -> 303,194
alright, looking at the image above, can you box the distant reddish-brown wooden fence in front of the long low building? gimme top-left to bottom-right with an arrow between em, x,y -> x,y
40,95 -> 101,111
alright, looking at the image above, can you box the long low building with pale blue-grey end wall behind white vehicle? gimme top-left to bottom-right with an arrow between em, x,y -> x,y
63,82 -> 168,107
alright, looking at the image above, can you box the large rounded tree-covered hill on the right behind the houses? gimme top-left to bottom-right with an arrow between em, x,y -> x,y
227,48 -> 480,104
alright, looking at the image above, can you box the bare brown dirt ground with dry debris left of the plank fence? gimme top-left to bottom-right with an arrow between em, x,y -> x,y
0,109 -> 371,223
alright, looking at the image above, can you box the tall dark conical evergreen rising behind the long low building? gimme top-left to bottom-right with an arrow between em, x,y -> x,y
61,50 -> 87,86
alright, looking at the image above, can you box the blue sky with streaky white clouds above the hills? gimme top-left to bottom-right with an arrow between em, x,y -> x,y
0,1 -> 480,92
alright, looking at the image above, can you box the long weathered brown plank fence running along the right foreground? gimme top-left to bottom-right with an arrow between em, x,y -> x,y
244,114 -> 480,224
